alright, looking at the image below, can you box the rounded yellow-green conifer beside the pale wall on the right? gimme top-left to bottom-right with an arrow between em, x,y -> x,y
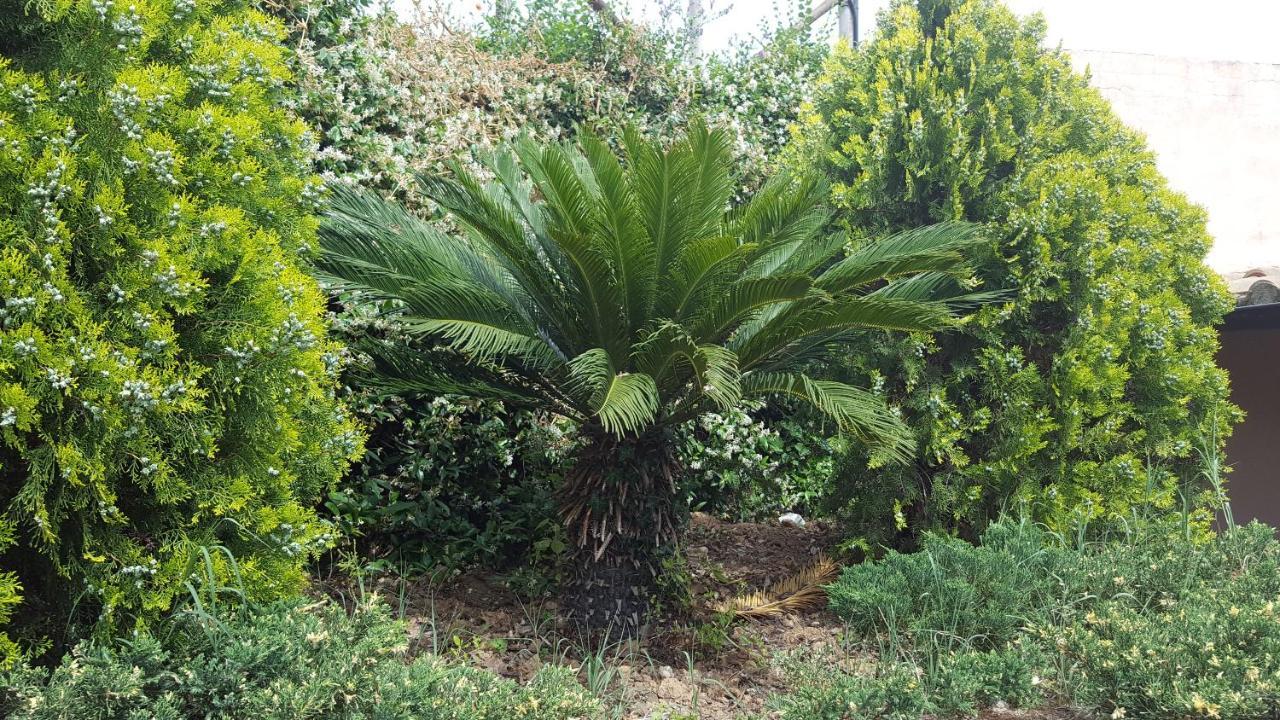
797,0 -> 1235,541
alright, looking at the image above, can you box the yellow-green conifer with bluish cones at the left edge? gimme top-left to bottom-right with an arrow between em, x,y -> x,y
0,0 -> 361,650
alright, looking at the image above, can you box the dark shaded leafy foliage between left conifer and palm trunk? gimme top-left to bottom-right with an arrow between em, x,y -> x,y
325,397 -> 572,568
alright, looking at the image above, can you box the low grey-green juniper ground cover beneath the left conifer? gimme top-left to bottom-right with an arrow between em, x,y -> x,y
0,594 -> 599,720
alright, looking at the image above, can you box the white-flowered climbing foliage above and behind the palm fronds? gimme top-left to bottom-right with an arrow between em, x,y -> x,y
281,0 -> 826,206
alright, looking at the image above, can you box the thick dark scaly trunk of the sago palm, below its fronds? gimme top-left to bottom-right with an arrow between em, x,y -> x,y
559,433 -> 689,637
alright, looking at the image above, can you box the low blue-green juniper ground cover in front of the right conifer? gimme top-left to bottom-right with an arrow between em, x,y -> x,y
798,518 -> 1280,719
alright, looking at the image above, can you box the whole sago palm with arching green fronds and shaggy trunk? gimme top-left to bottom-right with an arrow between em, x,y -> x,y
320,126 -> 974,632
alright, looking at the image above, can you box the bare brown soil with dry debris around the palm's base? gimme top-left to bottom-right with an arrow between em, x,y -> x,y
317,512 -> 844,720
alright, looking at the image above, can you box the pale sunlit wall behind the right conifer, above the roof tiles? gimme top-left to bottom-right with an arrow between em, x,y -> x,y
1069,50 -> 1280,273
